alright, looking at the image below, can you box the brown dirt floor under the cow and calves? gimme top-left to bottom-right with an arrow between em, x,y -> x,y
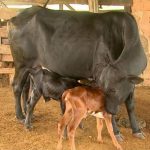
0,87 -> 150,150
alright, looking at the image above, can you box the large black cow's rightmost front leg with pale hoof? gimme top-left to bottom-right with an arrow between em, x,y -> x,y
125,92 -> 145,139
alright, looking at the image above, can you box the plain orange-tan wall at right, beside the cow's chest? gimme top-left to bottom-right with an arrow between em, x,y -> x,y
132,0 -> 150,86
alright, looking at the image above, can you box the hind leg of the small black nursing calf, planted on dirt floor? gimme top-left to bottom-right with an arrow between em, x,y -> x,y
25,89 -> 41,129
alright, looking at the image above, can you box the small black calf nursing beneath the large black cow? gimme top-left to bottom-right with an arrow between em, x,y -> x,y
25,67 -> 80,128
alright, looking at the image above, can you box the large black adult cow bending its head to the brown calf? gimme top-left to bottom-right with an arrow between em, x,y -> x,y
9,6 -> 147,139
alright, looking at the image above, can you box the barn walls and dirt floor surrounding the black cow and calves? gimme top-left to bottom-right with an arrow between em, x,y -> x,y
0,0 -> 150,150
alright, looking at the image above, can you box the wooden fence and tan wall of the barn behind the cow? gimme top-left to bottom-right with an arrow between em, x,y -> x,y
0,0 -> 150,86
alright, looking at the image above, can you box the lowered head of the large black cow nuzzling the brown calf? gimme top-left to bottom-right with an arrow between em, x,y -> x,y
98,64 -> 143,114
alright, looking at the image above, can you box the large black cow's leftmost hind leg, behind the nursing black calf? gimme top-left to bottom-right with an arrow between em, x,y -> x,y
12,68 -> 29,120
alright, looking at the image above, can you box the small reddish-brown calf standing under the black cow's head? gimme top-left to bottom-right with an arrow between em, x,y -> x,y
57,86 -> 122,150
